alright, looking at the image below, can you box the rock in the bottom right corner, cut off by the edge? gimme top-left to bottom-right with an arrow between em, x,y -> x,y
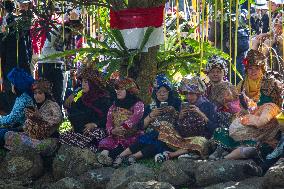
264,158 -> 284,188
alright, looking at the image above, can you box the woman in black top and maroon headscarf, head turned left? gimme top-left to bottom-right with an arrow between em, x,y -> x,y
60,67 -> 111,152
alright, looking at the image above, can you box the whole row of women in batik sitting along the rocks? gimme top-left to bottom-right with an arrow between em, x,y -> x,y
0,50 -> 284,176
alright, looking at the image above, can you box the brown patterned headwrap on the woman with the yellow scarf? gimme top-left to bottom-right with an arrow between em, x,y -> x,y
243,49 -> 266,72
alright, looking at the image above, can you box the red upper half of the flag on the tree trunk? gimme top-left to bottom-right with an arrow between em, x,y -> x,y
110,6 -> 164,30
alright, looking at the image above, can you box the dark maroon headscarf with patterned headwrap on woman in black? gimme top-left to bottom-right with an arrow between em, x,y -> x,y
78,67 -> 109,117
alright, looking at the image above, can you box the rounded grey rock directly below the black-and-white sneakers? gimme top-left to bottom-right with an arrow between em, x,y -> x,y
158,161 -> 195,187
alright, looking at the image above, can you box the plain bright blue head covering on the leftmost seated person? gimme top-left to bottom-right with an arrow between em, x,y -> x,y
7,68 -> 34,92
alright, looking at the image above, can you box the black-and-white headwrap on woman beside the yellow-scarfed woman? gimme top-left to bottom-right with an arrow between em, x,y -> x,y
204,55 -> 228,75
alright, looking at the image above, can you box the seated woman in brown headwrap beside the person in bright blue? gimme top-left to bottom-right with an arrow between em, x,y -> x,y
5,79 -> 62,152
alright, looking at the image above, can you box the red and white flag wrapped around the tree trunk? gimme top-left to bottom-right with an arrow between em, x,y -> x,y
110,6 -> 164,52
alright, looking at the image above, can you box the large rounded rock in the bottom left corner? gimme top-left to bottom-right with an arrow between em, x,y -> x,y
0,146 -> 43,182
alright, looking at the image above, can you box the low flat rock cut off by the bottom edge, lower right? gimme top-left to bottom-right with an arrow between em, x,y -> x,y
204,177 -> 265,189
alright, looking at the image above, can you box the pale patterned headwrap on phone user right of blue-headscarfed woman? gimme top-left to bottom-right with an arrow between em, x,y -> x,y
179,76 -> 206,94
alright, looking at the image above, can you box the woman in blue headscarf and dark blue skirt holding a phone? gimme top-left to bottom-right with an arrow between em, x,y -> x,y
110,74 -> 181,167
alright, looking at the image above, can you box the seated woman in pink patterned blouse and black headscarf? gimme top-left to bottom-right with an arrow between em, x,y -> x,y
98,78 -> 144,165
